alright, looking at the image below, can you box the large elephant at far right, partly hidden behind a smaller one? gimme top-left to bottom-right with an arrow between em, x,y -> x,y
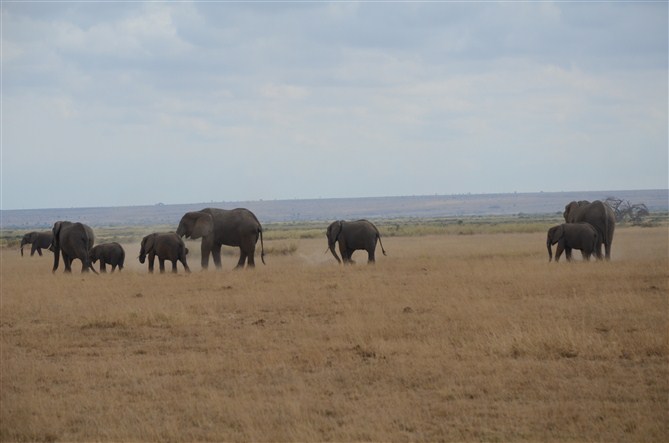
562,200 -> 616,260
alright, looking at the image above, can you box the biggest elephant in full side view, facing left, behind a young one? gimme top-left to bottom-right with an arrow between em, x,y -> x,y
177,208 -> 265,270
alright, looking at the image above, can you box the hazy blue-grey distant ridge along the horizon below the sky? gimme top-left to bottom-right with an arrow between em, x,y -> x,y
0,189 -> 669,229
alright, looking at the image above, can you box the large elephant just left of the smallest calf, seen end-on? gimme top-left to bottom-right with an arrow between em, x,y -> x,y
50,221 -> 97,274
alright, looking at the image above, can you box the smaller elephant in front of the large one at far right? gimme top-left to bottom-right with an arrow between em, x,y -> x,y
546,222 -> 601,263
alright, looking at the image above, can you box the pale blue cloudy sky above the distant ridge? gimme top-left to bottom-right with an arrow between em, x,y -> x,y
1,2 -> 669,209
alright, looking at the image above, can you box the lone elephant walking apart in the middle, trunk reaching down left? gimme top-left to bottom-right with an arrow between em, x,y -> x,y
326,220 -> 386,264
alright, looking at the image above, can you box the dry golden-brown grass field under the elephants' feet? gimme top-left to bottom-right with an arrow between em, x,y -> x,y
0,226 -> 669,442
